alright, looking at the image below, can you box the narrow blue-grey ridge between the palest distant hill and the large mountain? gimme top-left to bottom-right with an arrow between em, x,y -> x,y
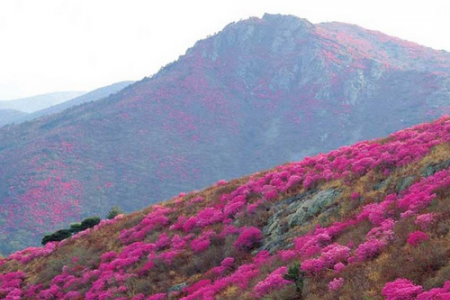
15,81 -> 133,124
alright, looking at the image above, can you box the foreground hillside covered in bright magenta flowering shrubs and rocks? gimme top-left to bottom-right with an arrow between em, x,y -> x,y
0,117 -> 450,300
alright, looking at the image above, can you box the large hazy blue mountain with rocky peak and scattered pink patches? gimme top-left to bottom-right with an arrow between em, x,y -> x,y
0,15 -> 450,254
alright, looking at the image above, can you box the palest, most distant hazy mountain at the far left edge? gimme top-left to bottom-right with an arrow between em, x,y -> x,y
0,92 -> 85,113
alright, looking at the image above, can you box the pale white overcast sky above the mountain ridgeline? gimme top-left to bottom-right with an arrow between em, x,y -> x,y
0,0 -> 450,100
